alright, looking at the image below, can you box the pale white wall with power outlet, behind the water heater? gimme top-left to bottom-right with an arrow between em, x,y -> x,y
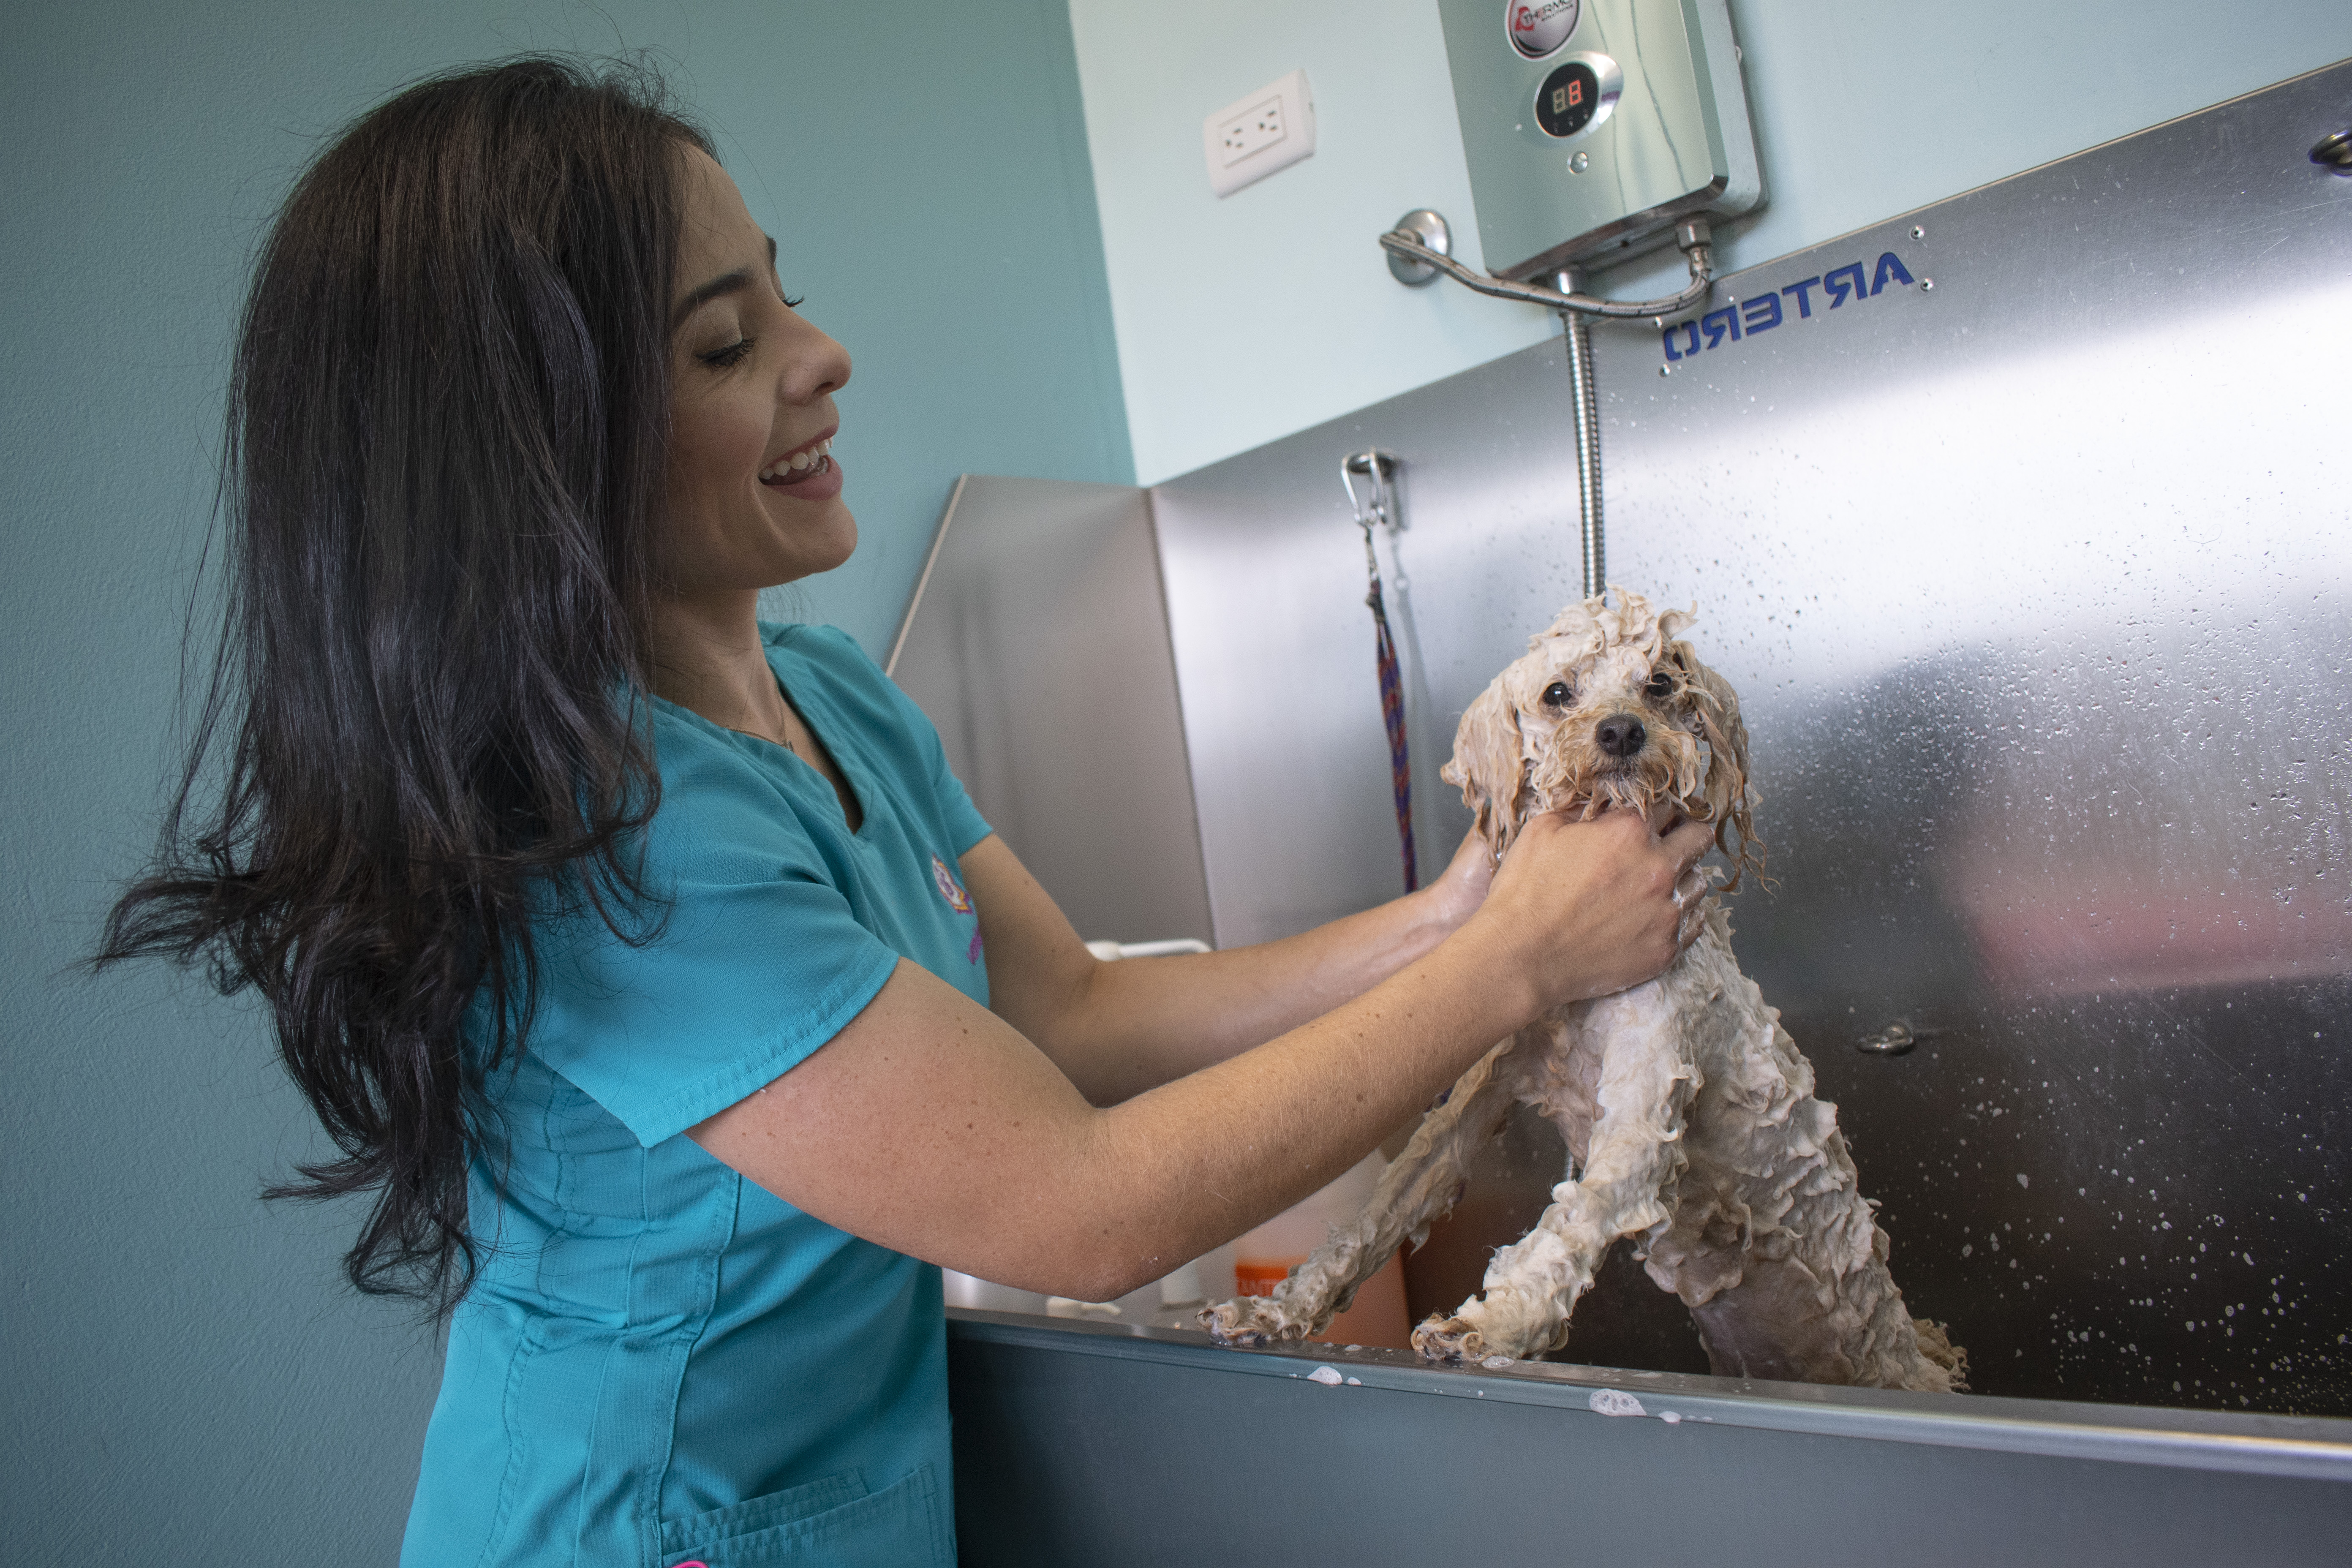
1070,0 -> 2352,484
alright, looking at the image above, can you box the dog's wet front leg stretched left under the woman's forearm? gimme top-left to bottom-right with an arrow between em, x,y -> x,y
1200,1023 -> 1543,1345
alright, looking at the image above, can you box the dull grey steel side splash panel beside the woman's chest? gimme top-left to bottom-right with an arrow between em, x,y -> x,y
891,475 -> 1209,943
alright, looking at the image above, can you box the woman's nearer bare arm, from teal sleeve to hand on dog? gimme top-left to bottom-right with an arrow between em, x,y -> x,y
691,811 -> 1710,1300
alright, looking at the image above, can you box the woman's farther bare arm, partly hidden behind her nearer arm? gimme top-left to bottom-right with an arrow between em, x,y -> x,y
960,835 -> 1494,1105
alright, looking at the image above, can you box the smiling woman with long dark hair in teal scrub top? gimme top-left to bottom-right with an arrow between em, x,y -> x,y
106,59 -> 1707,1568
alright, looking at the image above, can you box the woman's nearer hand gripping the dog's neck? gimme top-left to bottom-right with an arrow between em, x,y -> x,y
1449,811 -> 1715,1013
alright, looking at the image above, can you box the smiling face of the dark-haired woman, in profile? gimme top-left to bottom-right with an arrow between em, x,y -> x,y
663,148 -> 858,597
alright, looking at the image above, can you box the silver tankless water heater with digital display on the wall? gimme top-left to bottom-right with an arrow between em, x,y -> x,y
1437,0 -> 1764,280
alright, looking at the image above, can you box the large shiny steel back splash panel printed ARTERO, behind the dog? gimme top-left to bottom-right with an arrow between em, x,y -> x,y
1155,63 -> 2352,1413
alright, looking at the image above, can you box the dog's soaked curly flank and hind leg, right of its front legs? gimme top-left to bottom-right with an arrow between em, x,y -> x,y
1649,940 -> 1966,1394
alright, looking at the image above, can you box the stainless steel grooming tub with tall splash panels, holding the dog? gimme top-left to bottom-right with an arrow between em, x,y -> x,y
901,63 -> 2352,1563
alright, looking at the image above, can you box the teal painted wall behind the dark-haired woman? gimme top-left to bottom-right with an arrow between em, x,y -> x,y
0,0 -> 1129,1568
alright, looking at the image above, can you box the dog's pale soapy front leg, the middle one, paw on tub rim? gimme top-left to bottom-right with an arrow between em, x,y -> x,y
1413,980 -> 1698,1361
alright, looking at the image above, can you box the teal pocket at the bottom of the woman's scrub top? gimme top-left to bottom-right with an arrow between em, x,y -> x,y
659,1462 -> 955,1568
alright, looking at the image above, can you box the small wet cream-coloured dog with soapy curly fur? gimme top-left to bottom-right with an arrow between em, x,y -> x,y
1202,590 -> 1966,1392
